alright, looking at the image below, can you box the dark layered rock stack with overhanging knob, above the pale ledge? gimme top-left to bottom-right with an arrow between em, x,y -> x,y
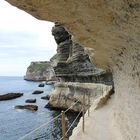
52,23 -> 112,84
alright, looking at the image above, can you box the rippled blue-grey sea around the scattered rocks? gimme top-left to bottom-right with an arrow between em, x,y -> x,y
0,76 -> 79,140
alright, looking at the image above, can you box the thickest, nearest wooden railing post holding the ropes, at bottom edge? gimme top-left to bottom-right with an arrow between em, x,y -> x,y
61,111 -> 66,140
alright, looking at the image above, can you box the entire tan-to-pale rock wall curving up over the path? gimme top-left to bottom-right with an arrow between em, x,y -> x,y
4,0 -> 140,140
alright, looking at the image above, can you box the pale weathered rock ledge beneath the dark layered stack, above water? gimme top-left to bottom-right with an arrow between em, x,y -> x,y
45,82 -> 112,112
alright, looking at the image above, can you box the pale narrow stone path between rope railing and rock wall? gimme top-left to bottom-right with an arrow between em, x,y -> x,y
70,95 -> 122,140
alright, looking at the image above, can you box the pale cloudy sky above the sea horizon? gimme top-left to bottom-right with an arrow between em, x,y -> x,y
0,0 -> 56,76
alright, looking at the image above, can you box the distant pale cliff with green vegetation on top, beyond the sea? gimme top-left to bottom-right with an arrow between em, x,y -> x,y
24,61 -> 56,81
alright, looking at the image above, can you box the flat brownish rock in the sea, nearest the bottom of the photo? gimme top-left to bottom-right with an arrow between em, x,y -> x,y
15,105 -> 38,111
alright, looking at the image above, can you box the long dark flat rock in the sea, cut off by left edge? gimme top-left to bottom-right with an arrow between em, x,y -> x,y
0,93 -> 23,101
